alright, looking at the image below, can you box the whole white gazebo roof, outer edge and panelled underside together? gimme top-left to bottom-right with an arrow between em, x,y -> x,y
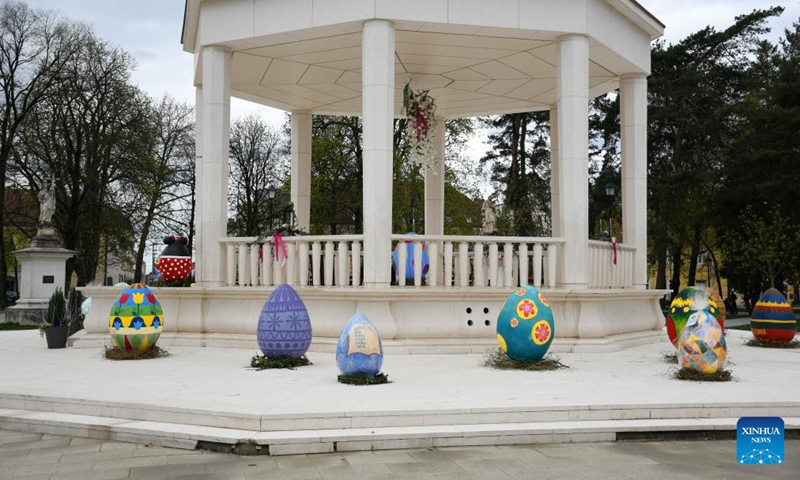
182,0 -> 664,117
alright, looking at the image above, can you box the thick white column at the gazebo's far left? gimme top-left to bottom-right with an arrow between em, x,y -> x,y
195,46 -> 231,286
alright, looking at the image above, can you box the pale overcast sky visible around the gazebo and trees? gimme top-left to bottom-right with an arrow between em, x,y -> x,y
20,0 -> 800,125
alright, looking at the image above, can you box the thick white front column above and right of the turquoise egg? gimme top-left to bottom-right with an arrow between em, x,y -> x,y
556,35 -> 589,289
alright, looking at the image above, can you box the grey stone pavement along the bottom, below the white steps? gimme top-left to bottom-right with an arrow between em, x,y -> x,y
0,431 -> 800,480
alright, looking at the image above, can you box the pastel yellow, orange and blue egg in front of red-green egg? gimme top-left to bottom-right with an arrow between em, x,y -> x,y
678,310 -> 727,375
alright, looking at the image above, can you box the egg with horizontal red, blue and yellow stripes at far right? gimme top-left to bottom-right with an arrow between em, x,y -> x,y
750,288 -> 797,343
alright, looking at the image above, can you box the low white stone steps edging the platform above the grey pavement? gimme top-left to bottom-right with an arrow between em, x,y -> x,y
0,410 -> 800,455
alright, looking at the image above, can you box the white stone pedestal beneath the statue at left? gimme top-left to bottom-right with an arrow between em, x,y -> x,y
6,222 -> 75,325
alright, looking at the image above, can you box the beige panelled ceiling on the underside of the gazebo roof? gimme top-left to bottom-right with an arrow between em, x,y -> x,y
184,0 -> 663,117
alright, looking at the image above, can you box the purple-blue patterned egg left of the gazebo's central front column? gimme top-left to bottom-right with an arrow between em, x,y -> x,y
257,285 -> 311,358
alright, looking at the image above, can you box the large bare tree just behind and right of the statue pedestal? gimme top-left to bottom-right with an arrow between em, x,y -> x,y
15,29 -> 152,285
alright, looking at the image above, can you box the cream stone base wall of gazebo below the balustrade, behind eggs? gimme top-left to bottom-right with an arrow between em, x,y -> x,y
74,287 -> 664,354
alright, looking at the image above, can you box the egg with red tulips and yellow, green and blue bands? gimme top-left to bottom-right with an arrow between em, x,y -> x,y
108,283 -> 164,352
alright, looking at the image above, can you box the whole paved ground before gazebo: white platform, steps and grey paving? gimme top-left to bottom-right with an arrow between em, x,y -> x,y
0,331 -> 800,479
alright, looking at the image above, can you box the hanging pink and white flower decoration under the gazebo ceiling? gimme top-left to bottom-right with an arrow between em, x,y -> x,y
403,83 -> 437,171
